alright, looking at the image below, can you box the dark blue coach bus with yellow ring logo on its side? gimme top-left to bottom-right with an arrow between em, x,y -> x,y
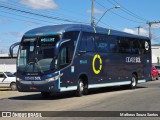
11,24 -> 152,97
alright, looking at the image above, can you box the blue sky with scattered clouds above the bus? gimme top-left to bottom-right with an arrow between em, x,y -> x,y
0,0 -> 160,54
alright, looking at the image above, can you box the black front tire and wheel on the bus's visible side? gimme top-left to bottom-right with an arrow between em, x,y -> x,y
76,79 -> 88,97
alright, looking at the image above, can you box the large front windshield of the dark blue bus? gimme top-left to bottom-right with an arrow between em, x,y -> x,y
17,35 -> 60,73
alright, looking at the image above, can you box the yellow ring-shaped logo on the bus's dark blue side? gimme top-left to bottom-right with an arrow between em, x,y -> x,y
92,54 -> 102,74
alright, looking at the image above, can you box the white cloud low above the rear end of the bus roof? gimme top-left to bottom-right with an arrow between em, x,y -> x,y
123,28 -> 148,37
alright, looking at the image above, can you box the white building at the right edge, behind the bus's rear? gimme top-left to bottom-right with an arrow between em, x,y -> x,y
152,44 -> 160,65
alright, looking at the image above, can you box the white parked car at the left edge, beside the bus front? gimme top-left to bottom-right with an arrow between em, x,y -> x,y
0,72 -> 17,90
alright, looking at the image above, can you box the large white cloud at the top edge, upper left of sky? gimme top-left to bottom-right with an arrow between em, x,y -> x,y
20,0 -> 58,10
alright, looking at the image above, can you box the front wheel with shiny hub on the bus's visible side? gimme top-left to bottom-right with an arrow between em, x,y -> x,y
76,79 -> 85,97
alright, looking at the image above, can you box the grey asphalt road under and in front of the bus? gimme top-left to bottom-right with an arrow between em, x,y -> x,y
0,80 -> 160,120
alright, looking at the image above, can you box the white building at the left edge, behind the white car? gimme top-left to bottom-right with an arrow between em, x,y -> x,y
0,54 -> 16,73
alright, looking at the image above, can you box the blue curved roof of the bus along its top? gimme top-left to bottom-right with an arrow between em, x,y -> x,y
24,24 -> 149,39
